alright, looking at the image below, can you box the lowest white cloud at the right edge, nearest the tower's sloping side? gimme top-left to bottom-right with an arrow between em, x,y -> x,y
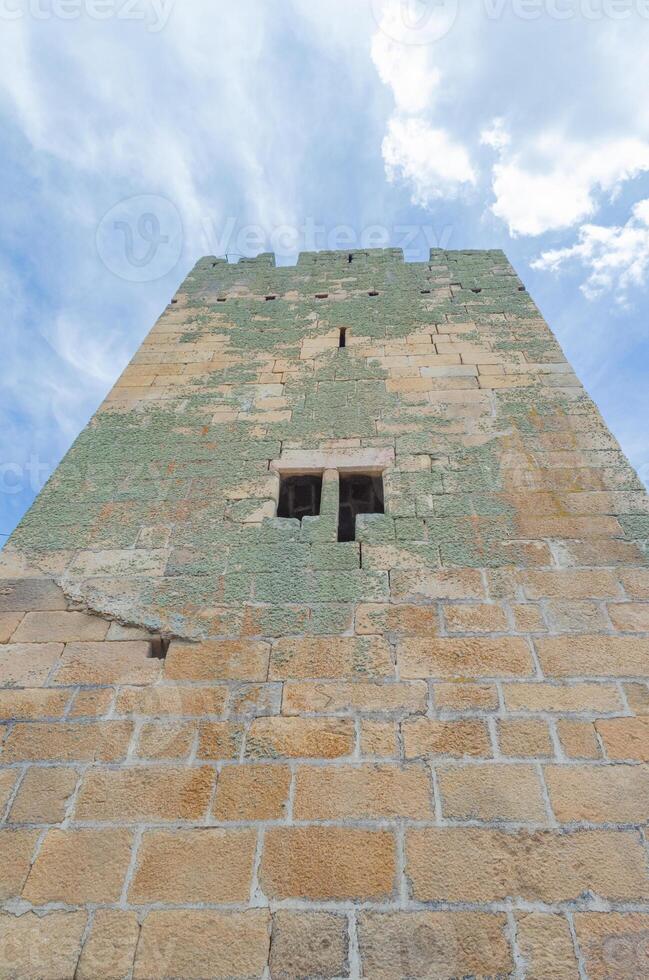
532,198 -> 649,304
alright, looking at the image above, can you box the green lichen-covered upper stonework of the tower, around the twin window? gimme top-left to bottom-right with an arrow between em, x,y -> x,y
8,250 -> 649,636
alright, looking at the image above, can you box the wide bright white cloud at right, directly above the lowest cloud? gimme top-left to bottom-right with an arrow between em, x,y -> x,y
492,133 -> 649,235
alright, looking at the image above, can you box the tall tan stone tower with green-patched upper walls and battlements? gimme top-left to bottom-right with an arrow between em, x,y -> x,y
0,250 -> 649,980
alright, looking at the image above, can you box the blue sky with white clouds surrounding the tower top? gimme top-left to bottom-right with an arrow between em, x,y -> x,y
0,0 -> 649,543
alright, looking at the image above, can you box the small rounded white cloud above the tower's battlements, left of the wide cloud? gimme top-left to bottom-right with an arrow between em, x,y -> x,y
383,116 -> 476,205
